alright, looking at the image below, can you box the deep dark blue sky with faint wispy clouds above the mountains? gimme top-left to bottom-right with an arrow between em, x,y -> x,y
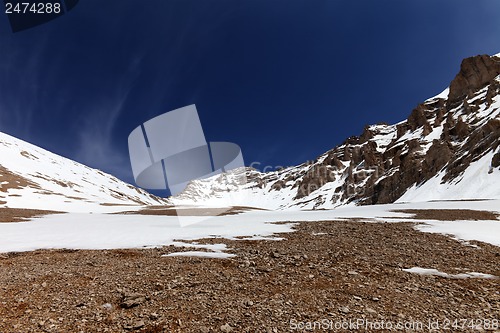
0,0 -> 500,187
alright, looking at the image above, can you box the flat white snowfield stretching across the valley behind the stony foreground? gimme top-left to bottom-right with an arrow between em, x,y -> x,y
0,200 -> 500,252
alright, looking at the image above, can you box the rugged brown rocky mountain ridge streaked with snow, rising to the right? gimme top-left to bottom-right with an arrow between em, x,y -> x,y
175,55 -> 500,209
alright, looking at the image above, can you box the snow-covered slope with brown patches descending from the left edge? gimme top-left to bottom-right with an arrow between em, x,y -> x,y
0,133 -> 167,212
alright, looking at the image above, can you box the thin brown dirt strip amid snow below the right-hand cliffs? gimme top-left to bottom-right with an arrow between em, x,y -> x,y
393,209 -> 499,221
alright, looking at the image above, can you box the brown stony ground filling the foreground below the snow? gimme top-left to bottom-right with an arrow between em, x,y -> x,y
0,215 -> 500,332
